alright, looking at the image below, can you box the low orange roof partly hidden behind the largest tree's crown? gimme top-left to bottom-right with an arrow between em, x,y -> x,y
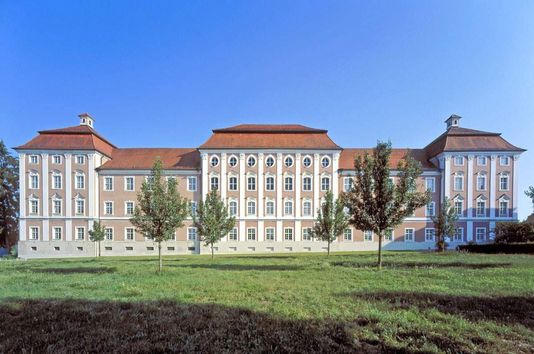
339,148 -> 436,170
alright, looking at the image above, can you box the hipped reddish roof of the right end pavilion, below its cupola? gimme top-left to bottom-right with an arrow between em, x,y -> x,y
425,127 -> 525,158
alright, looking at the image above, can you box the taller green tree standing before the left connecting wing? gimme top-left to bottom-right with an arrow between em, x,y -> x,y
130,158 -> 189,272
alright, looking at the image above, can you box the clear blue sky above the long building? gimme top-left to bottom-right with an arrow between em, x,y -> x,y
0,0 -> 534,217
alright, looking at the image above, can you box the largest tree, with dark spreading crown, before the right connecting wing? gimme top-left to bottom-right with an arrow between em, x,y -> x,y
344,142 -> 431,269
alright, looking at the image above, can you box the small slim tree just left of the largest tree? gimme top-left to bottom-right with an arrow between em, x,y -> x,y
311,191 -> 349,256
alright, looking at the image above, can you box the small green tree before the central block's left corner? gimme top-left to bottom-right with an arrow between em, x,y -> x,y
193,190 -> 235,259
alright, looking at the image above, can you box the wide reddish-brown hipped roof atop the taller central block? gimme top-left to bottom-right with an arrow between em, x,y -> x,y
199,124 -> 341,150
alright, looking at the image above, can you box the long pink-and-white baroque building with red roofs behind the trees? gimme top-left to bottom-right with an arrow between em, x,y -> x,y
16,114 -> 525,258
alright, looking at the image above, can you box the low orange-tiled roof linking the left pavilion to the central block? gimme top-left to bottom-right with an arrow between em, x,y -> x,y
99,148 -> 200,170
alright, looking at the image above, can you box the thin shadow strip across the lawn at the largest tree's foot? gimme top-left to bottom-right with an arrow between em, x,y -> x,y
331,261 -> 512,269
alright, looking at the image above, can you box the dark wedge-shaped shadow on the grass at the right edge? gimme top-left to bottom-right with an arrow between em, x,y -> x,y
343,292 -> 534,329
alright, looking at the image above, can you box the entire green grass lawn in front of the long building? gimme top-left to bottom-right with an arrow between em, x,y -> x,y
0,252 -> 534,353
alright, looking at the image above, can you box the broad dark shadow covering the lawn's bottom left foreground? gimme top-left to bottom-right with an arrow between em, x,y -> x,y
0,299 -> 376,353
